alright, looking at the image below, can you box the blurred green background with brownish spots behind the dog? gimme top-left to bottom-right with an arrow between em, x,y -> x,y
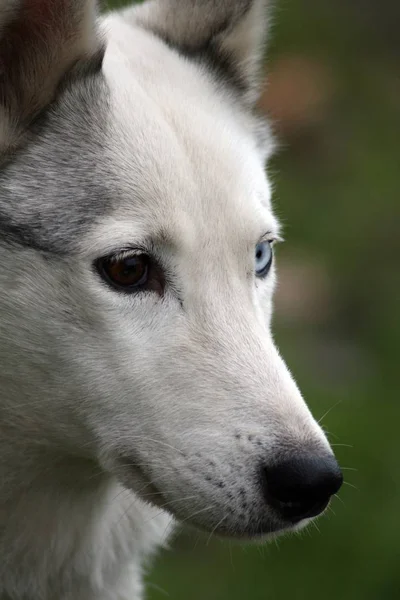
109,0 -> 400,600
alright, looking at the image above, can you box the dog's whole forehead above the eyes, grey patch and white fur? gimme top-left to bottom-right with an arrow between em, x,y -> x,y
0,21 -> 275,253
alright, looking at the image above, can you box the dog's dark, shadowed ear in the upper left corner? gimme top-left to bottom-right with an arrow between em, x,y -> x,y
0,0 -> 101,153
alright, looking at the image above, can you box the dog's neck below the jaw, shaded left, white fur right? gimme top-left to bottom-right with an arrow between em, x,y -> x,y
0,427 -> 171,600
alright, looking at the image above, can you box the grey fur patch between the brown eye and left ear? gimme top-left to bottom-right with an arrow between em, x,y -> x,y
0,71 -> 111,255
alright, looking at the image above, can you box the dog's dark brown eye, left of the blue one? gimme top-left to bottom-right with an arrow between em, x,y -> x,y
96,254 -> 150,292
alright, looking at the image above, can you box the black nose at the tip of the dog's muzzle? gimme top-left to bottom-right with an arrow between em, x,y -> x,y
264,455 -> 343,523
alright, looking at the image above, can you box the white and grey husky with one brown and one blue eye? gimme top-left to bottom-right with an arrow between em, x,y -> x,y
0,0 -> 342,600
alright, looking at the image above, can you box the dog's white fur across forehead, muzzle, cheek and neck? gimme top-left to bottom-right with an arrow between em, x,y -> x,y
0,2 -> 338,600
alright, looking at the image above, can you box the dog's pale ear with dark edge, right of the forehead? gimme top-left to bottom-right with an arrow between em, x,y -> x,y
136,0 -> 269,103
